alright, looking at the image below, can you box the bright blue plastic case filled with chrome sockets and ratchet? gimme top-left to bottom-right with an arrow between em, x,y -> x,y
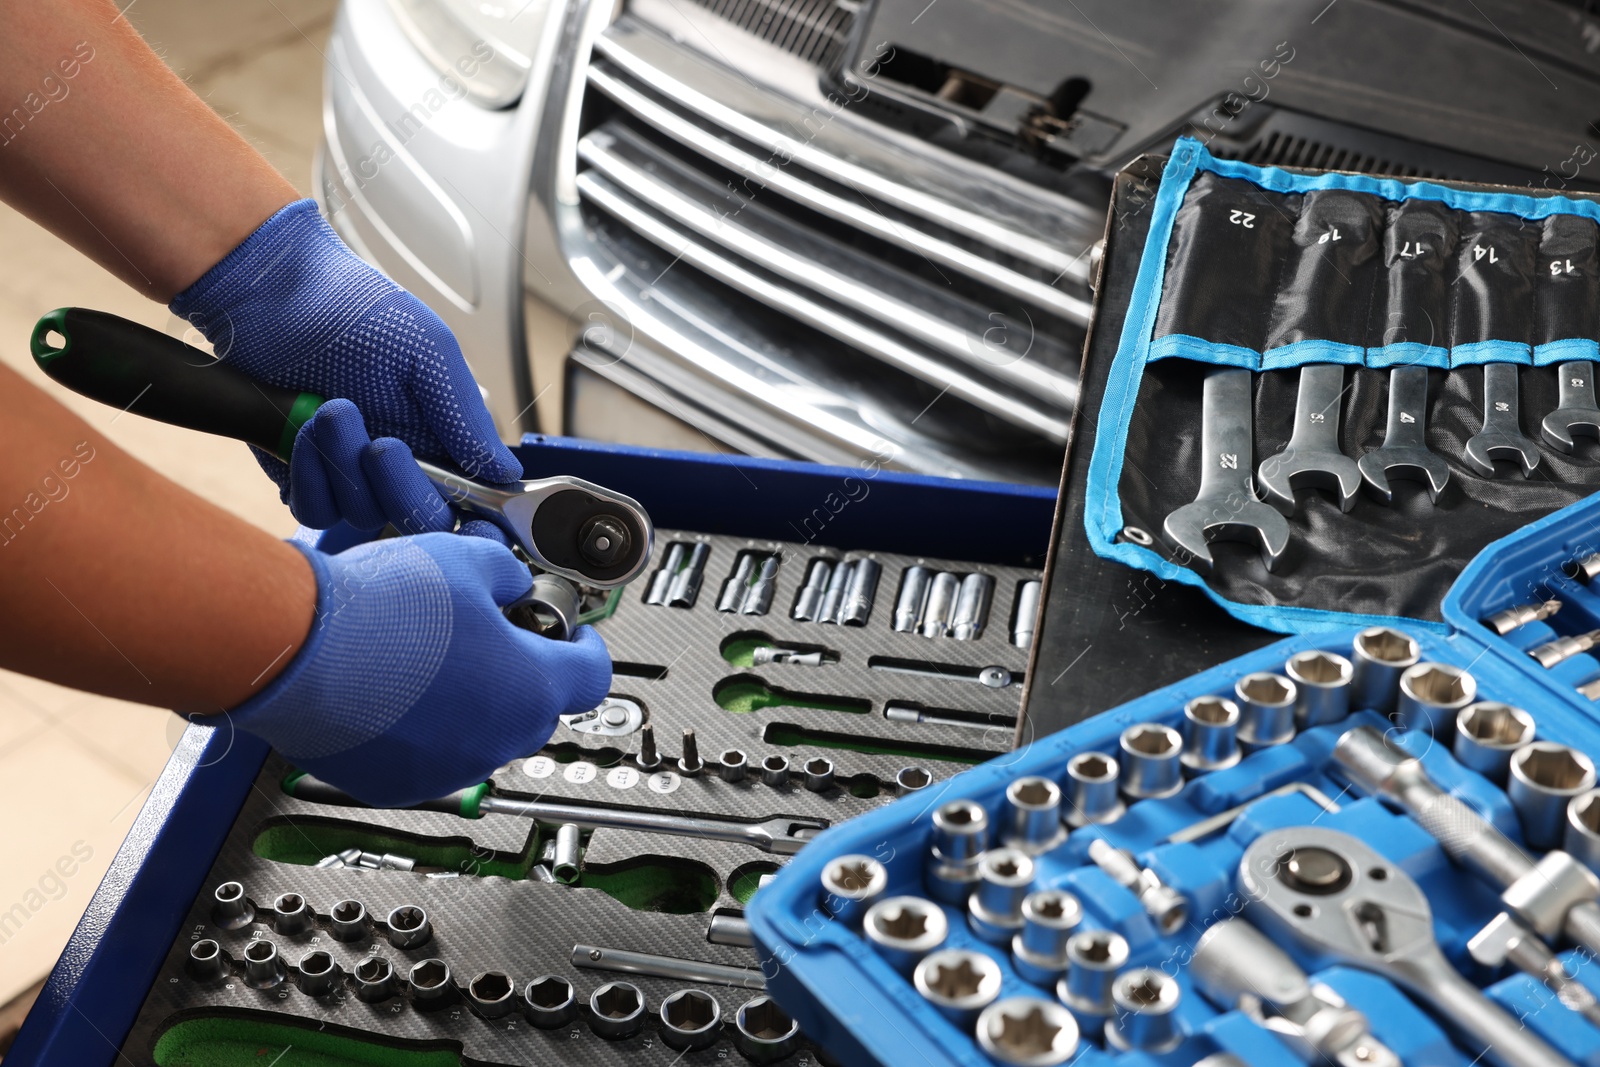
749,489 -> 1600,1067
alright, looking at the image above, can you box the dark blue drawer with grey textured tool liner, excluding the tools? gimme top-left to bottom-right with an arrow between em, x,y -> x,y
11,438 -> 1053,1064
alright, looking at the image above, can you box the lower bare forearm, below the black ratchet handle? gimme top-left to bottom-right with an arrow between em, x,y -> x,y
0,368 -> 317,712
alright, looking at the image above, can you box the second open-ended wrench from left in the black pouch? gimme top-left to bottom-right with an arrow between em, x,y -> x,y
1256,363 -> 1362,515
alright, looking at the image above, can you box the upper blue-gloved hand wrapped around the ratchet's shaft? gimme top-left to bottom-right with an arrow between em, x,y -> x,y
171,200 -> 522,530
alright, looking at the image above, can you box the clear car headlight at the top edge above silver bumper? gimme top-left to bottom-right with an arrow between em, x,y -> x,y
389,0 -> 562,107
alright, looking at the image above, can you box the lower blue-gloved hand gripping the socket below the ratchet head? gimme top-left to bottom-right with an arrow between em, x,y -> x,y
230,533 -> 611,806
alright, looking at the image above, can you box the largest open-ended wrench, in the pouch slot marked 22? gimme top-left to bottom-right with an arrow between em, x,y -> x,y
1162,370 -> 1290,571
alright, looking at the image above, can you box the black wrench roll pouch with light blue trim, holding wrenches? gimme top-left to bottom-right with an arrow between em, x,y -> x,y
1085,139 -> 1600,632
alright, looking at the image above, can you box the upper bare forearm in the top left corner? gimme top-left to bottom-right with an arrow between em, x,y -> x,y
0,0 -> 296,302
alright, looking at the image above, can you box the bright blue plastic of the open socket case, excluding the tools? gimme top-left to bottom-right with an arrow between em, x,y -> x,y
750,498 -> 1600,1067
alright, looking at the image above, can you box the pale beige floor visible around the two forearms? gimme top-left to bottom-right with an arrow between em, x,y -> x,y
0,0 -> 334,1003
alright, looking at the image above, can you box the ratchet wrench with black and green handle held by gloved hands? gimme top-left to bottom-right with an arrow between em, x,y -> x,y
32,307 -> 654,589
